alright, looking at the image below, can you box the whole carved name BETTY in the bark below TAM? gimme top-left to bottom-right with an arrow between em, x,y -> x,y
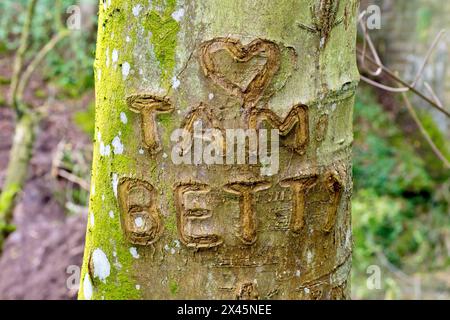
118,171 -> 344,249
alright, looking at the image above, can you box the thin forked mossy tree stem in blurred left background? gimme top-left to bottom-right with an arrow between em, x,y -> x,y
0,0 -> 69,252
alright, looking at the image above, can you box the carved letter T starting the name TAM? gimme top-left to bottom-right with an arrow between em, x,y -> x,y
127,94 -> 174,154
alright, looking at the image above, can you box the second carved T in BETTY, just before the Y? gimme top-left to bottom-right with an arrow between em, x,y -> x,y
281,175 -> 317,234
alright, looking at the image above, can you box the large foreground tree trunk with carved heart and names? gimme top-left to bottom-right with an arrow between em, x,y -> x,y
79,0 -> 358,299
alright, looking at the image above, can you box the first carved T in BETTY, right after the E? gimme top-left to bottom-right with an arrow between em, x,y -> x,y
224,181 -> 270,245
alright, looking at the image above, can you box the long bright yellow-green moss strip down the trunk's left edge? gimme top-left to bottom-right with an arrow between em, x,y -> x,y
79,1 -> 140,299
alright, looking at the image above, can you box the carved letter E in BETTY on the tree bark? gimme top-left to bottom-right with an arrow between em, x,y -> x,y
175,183 -> 222,248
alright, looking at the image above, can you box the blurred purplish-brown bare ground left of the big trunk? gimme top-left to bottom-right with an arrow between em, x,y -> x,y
0,56 -> 92,300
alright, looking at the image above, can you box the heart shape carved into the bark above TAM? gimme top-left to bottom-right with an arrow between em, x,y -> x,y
200,38 -> 281,110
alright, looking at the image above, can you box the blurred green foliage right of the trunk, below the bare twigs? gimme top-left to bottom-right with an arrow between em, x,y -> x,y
352,86 -> 450,298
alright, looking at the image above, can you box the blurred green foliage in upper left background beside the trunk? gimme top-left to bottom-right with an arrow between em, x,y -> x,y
0,0 -> 97,98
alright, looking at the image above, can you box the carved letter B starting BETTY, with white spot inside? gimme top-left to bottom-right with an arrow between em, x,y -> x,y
118,178 -> 162,245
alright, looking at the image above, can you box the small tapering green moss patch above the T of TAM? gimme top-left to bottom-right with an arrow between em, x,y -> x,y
144,0 -> 180,86
